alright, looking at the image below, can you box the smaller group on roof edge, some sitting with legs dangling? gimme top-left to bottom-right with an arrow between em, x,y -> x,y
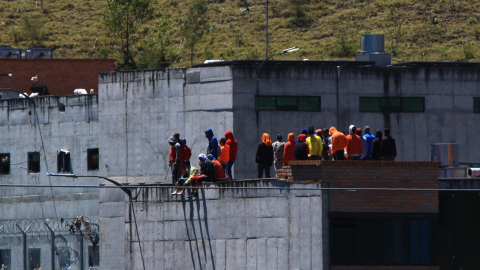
168,129 -> 238,197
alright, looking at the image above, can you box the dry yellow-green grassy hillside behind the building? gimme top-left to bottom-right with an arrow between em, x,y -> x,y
0,0 -> 480,66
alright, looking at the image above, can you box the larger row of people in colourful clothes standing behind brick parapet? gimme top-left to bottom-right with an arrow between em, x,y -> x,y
255,125 -> 397,178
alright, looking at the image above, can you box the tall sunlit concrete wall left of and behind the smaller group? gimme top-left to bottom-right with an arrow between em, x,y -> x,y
98,67 -> 233,183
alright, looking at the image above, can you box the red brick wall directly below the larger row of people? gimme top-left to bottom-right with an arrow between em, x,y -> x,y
279,161 -> 439,213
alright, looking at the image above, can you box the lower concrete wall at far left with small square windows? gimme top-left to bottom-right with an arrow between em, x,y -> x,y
0,95 -> 99,219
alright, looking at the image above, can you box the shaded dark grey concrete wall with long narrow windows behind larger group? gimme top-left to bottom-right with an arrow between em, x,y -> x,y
233,66 -> 480,178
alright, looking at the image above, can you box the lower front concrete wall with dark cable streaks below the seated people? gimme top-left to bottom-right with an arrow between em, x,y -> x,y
100,181 -> 328,269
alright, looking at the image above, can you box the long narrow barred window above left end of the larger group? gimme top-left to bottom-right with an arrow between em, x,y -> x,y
255,96 -> 321,112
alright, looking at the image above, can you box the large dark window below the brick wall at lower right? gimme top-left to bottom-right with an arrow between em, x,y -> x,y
330,216 -> 433,265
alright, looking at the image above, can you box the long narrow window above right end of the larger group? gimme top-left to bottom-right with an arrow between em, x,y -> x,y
360,97 -> 425,112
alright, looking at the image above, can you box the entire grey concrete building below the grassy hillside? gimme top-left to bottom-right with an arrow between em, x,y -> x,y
0,61 -> 480,269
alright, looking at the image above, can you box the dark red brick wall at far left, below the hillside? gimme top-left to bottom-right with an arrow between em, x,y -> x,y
0,58 -> 115,95
